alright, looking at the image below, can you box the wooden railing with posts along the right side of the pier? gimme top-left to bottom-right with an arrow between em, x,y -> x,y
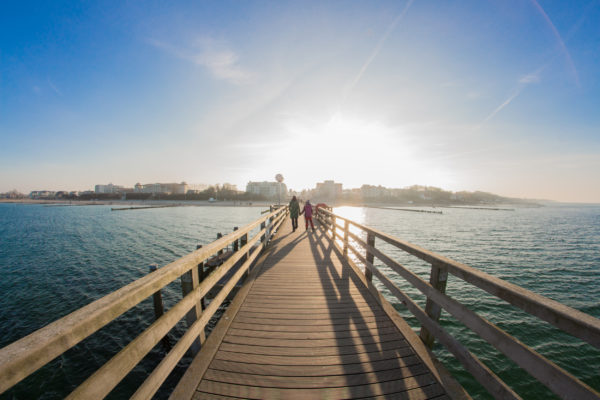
317,208 -> 600,399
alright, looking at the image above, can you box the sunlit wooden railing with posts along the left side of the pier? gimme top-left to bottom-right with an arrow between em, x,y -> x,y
0,206 -> 288,399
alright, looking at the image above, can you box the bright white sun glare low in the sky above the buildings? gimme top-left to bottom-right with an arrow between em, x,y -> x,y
281,113 -> 458,187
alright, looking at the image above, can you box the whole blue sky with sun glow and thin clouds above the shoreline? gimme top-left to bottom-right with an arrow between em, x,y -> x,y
0,0 -> 600,202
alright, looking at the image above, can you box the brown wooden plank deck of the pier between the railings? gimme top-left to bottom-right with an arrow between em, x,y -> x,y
171,220 -> 462,399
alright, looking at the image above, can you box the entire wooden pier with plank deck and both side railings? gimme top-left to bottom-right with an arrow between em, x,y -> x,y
0,207 -> 600,400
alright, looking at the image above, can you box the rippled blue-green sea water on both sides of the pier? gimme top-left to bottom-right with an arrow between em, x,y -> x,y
0,203 -> 600,400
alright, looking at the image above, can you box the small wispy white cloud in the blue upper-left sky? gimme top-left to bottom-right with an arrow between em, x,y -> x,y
149,38 -> 253,85
